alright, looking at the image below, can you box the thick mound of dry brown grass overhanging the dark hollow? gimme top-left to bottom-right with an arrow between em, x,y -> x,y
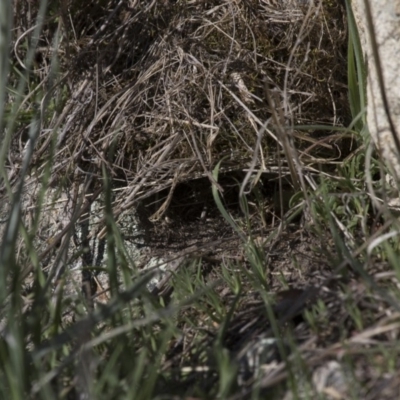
6,1 -> 349,233
